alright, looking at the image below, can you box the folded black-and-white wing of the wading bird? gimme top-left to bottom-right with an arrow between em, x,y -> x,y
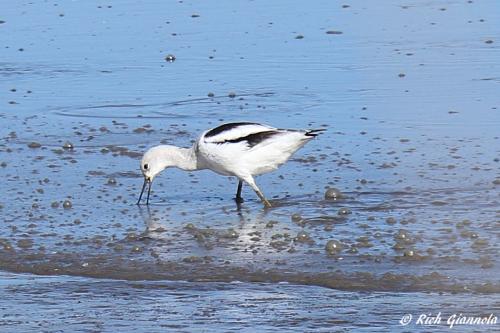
202,122 -> 282,147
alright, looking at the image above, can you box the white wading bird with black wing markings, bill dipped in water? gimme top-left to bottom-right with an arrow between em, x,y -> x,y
137,122 -> 325,207
